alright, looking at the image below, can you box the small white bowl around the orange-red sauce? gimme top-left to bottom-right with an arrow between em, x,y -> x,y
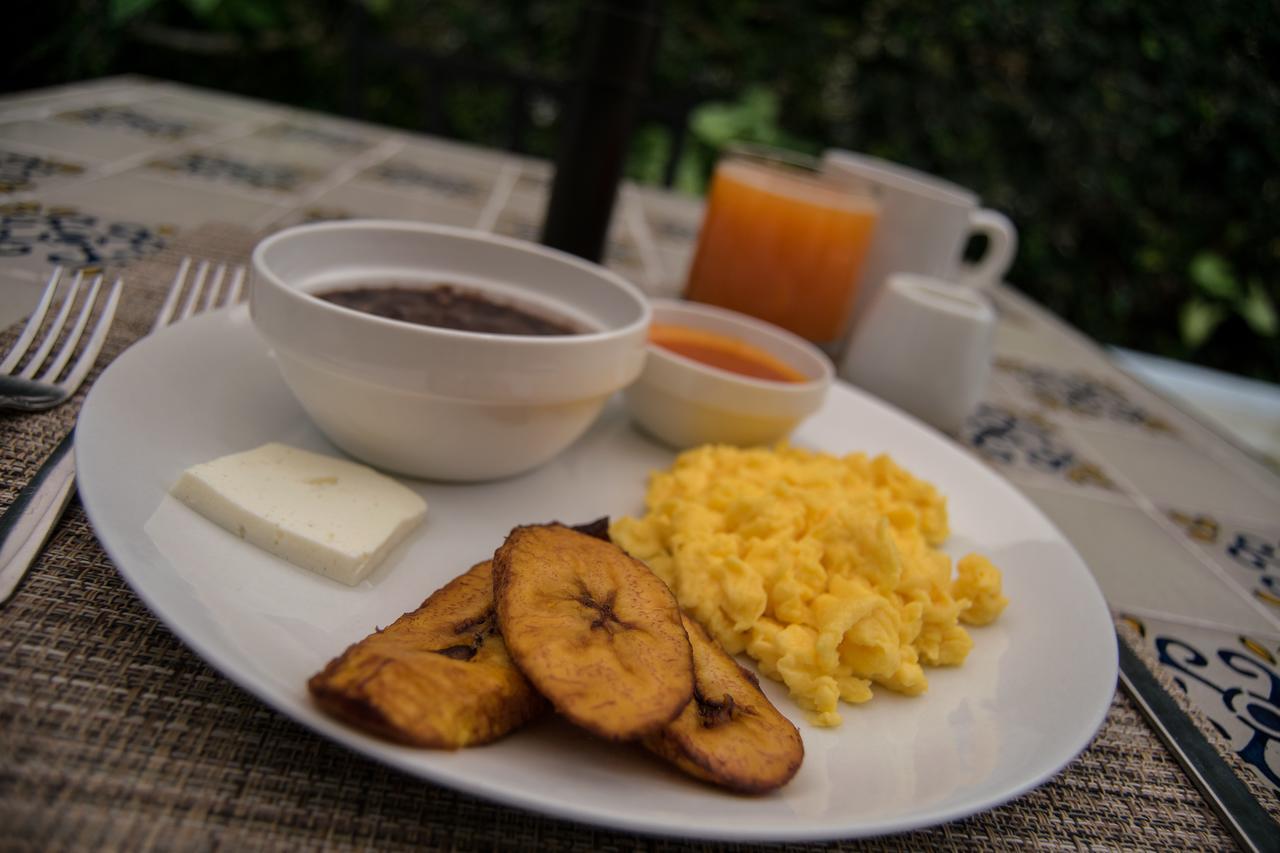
625,300 -> 835,450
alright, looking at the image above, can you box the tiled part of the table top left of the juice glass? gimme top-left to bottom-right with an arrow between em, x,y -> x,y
0,78 -> 700,320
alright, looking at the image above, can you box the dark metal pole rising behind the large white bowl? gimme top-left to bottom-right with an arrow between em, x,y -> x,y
543,0 -> 658,261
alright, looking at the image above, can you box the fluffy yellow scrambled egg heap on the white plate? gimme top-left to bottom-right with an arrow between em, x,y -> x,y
609,444 -> 1007,726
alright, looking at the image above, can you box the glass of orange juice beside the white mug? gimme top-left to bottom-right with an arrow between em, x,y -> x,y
685,146 -> 878,355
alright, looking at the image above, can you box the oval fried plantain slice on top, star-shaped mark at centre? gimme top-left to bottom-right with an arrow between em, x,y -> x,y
493,524 -> 694,740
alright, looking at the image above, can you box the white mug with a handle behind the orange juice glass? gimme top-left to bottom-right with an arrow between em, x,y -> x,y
822,149 -> 1018,308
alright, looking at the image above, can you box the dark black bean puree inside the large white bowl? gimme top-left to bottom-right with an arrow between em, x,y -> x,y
316,284 -> 582,334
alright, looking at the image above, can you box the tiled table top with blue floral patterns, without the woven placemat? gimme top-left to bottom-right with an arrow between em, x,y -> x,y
0,78 -> 1280,792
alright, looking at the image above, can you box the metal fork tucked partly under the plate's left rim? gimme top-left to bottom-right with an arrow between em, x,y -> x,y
0,257 -> 244,603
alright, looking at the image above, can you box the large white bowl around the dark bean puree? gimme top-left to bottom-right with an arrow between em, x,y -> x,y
250,220 -> 650,480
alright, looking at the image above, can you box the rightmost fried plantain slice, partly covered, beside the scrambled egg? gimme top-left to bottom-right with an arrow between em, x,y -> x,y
641,616 -> 804,794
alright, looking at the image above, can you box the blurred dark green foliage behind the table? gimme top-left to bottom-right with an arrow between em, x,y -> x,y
10,0 -> 1280,382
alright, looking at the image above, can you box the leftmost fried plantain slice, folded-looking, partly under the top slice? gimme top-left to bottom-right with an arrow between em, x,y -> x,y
307,560 -> 547,749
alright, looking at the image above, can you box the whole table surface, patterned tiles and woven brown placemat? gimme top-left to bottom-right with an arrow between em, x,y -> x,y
0,77 -> 1280,849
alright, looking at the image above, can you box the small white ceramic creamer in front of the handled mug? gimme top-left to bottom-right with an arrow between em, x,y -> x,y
840,273 -> 996,433
